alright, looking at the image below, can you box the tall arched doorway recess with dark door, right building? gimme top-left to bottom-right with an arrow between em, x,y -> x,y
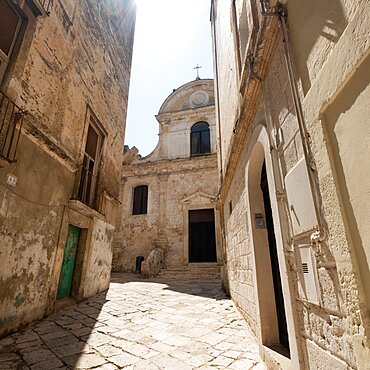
248,143 -> 290,357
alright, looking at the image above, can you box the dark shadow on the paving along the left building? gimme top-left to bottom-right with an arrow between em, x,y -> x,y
0,291 -> 108,370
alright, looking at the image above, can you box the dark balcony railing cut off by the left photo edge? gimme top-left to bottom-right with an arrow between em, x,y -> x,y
0,91 -> 25,162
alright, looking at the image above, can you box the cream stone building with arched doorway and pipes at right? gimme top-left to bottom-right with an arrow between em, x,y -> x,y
211,0 -> 370,369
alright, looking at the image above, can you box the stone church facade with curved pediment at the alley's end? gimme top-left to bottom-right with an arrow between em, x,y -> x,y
113,79 -> 222,274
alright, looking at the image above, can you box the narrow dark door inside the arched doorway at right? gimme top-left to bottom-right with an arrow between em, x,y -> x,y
261,163 -> 289,351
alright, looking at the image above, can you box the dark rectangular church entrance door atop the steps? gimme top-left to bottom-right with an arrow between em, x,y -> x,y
189,209 -> 217,262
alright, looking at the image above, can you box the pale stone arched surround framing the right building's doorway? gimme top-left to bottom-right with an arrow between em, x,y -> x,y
246,126 -> 303,369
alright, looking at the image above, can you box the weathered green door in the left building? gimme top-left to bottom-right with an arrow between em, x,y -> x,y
57,225 -> 80,299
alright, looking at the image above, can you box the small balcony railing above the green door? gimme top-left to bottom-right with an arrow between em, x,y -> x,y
77,166 -> 99,210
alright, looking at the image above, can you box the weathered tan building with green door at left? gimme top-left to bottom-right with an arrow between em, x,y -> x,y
0,0 -> 136,335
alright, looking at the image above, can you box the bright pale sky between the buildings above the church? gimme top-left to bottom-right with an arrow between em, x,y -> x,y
125,0 -> 213,156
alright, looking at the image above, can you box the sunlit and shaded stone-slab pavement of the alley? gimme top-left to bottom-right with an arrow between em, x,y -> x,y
0,274 -> 266,370
